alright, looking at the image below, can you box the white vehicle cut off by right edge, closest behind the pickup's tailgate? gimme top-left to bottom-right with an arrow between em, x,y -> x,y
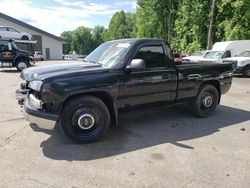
223,49 -> 250,77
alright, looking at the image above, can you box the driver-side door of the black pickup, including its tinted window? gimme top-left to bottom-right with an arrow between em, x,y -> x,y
120,41 -> 177,107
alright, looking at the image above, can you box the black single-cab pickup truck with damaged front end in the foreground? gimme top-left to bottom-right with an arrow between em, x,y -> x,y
17,39 -> 233,143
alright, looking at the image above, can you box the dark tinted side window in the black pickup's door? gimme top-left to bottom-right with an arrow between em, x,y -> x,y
133,45 -> 166,68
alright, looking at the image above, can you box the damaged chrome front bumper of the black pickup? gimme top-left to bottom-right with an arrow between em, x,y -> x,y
16,89 -> 59,129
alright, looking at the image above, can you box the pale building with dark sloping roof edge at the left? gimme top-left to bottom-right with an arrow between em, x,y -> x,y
0,12 -> 64,60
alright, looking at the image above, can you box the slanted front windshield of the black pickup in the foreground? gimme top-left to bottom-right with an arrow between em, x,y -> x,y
84,41 -> 131,68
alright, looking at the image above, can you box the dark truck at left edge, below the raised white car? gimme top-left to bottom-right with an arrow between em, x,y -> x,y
0,38 -> 34,71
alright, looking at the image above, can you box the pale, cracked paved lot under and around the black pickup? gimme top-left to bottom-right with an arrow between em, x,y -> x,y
0,61 -> 250,188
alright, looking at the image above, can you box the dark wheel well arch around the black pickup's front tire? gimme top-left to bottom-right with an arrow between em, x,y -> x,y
61,91 -> 117,125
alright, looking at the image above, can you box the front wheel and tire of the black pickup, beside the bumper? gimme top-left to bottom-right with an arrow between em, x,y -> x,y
60,96 -> 110,143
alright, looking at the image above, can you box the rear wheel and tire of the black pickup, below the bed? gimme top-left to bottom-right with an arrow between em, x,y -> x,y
193,84 -> 219,118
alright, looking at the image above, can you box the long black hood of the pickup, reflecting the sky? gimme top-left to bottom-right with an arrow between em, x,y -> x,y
20,62 -> 108,81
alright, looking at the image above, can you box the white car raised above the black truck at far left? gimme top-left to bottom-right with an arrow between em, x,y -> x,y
0,26 -> 32,40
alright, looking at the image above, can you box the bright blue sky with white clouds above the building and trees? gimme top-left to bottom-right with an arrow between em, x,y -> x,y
0,0 -> 136,36
